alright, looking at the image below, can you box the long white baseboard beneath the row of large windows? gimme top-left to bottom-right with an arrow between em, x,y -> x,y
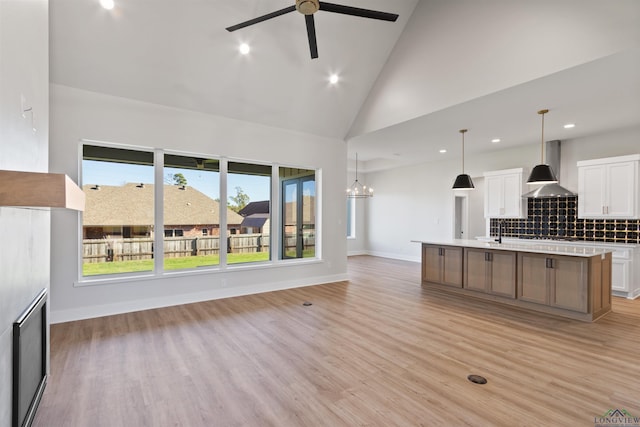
50,274 -> 349,324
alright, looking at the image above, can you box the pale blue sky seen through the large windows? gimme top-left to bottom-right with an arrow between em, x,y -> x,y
82,160 -> 270,202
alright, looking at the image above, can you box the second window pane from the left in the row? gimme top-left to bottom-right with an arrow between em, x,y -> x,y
162,154 -> 221,270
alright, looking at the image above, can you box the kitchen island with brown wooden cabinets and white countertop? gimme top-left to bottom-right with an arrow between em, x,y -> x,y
414,239 -> 611,321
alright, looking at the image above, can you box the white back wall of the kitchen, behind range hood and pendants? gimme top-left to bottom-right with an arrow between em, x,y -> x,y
366,128 -> 640,262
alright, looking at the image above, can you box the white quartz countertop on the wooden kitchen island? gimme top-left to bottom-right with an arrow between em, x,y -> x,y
412,239 -> 613,257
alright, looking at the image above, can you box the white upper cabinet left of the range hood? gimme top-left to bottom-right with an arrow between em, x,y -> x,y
483,168 -> 526,218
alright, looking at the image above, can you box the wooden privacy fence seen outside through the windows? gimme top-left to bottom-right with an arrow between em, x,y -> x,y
82,234 -> 276,263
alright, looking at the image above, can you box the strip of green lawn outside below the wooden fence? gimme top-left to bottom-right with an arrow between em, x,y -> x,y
82,252 -> 269,276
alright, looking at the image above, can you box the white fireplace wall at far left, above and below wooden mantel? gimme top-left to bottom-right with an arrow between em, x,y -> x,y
0,0 -> 50,427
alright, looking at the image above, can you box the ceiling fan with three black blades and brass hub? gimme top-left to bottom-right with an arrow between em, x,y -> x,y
227,0 -> 398,59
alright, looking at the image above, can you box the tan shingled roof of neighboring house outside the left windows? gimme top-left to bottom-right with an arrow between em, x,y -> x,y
82,183 -> 243,227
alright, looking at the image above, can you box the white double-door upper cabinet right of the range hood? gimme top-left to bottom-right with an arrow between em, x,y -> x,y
578,154 -> 640,219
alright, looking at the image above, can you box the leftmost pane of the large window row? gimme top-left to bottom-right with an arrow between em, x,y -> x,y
82,145 -> 155,276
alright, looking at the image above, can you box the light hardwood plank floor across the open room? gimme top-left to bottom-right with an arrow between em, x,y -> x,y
34,256 -> 640,427
